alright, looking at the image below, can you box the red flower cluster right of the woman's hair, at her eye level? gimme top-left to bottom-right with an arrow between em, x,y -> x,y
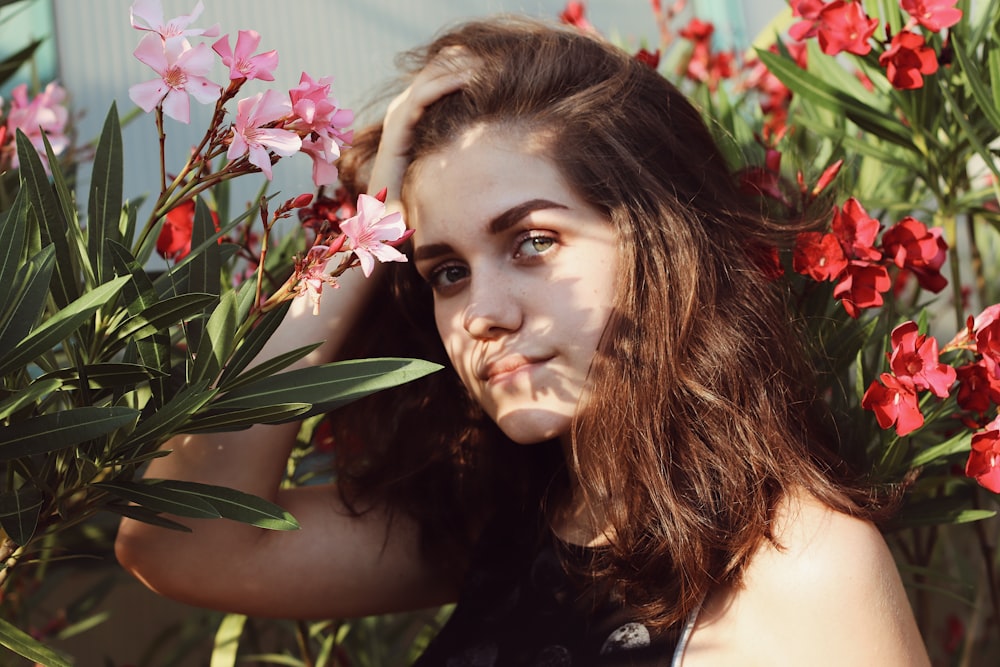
792,197 -> 948,318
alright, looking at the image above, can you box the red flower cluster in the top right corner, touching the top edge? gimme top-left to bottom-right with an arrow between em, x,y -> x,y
789,0 -> 962,90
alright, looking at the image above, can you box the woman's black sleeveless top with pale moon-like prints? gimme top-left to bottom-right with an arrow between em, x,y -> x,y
414,508 -> 684,667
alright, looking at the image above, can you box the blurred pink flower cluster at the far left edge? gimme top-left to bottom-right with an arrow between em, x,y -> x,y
0,82 -> 70,173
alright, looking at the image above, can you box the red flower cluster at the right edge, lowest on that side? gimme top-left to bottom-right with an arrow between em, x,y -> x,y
861,304 -> 1000,493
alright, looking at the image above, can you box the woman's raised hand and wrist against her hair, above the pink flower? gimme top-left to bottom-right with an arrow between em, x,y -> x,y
368,47 -> 475,210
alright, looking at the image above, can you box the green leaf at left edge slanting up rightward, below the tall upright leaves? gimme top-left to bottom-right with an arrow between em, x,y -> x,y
0,246 -> 55,359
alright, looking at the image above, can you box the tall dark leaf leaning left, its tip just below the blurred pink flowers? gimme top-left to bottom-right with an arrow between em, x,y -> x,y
14,130 -> 79,310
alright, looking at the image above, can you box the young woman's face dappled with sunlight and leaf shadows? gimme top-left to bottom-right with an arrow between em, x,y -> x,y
407,128 -> 618,444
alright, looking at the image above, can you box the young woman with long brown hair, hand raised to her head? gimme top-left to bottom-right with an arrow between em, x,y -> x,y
118,13 -> 927,667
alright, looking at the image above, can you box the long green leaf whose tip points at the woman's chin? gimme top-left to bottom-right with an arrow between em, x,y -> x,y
211,358 -> 441,418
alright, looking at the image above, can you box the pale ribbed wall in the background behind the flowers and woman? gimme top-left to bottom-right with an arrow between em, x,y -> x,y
53,0 -> 784,226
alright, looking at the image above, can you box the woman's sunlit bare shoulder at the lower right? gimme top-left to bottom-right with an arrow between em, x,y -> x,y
684,495 -> 929,667
